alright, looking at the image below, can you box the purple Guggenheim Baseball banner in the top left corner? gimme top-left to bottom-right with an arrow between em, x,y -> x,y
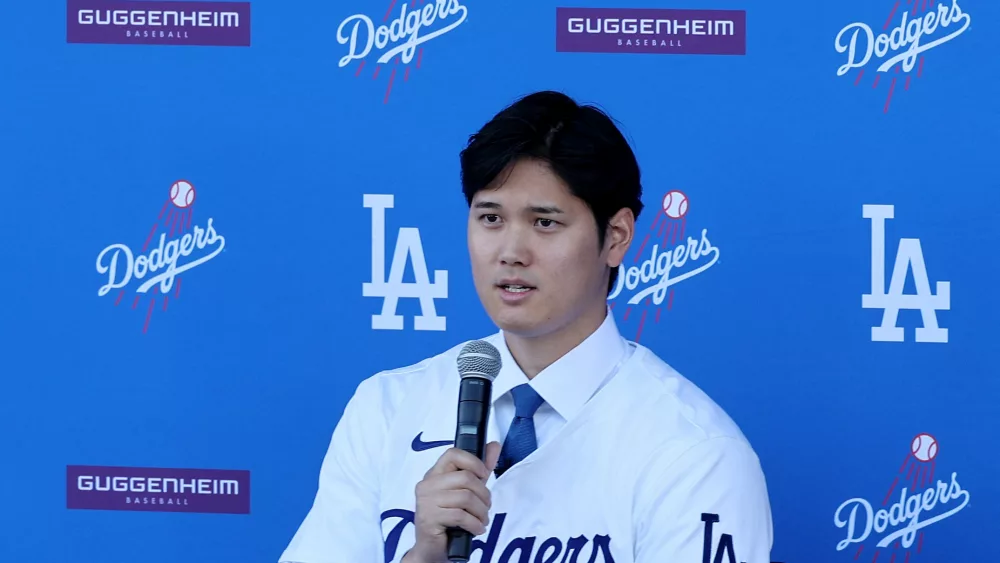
66,0 -> 250,47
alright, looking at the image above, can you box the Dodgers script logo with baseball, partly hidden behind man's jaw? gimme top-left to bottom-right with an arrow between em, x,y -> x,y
608,190 -> 719,342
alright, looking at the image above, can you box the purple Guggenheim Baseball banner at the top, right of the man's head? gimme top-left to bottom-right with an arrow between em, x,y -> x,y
556,8 -> 747,55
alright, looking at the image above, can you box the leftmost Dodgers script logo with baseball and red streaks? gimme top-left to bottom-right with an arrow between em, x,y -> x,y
97,180 -> 226,334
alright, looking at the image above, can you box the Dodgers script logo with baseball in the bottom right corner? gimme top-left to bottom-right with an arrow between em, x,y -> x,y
833,434 -> 969,563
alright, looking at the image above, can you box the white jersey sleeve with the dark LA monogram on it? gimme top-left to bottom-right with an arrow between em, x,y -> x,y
633,437 -> 773,563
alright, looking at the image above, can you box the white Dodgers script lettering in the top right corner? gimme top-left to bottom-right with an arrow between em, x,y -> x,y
834,0 -> 972,76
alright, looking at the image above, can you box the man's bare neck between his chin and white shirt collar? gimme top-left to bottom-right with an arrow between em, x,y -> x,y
504,303 -> 608,379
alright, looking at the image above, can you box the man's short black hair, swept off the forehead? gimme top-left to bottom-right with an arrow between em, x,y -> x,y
460,91 -> 643,294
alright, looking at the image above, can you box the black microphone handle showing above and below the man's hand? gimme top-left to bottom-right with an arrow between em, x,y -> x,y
447,376 -> 493,563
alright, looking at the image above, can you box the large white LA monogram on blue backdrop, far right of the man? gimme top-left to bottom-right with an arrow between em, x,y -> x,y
861,205 -> 951,343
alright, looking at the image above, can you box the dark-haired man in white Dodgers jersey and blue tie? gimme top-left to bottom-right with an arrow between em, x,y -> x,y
280,92 -> 772,563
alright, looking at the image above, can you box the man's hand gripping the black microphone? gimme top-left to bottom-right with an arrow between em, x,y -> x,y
402,442 -> 500,563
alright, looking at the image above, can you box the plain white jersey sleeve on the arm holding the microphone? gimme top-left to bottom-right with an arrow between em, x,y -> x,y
278,377 -> 387,563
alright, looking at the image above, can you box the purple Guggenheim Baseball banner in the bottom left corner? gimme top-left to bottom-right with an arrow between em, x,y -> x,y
66,465 -> 250,514
